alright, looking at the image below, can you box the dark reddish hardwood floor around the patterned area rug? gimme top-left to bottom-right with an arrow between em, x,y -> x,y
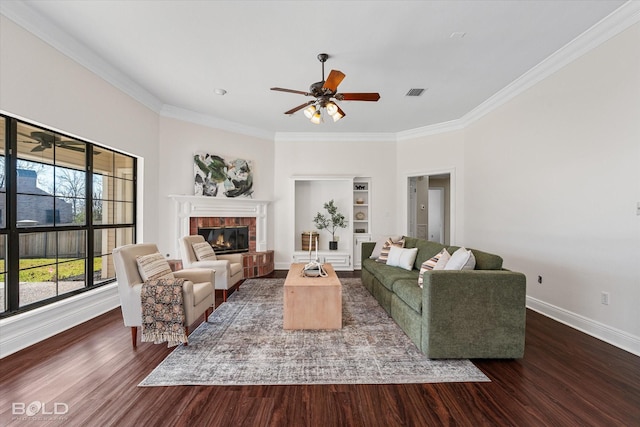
0,271 -> 640,427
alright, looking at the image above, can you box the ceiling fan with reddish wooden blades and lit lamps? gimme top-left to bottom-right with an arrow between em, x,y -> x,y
271,53 -> 380,124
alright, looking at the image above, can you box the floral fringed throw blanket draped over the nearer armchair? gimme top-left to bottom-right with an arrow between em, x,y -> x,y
140,279 -> 188,347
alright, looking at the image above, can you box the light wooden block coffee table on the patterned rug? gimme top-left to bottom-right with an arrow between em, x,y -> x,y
283,263 -> 342,329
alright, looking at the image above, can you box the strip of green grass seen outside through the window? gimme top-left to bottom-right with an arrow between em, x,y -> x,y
0,257 -> 102,282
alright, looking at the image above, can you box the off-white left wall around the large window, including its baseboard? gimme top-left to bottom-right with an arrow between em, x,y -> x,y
0,15 -> 159,357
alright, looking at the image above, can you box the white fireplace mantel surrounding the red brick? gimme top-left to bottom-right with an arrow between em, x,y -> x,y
169,194 -> 270,253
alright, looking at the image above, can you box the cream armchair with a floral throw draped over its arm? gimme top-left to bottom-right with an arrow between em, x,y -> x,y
113,243 -> 215,348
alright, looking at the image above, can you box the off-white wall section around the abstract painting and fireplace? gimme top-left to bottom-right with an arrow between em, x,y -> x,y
154,117 -> 274,258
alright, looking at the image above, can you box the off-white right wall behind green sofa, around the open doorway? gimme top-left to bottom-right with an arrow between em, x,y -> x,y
398,24 -> 640,354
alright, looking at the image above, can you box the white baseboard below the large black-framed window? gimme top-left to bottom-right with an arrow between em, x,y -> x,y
0,283 -> 120,359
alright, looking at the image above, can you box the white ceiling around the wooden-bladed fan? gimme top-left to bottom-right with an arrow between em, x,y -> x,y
3,0 -> 625,133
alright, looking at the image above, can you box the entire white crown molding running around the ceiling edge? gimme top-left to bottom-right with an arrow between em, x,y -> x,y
0,0 -> 640,142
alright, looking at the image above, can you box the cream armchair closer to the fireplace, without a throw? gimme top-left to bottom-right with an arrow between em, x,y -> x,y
180,236 -> 244,301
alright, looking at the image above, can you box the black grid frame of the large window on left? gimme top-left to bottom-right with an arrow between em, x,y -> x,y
0,114 -> 138,319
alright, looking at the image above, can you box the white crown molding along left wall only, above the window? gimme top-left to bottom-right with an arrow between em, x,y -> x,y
0,1 -> 162,113
